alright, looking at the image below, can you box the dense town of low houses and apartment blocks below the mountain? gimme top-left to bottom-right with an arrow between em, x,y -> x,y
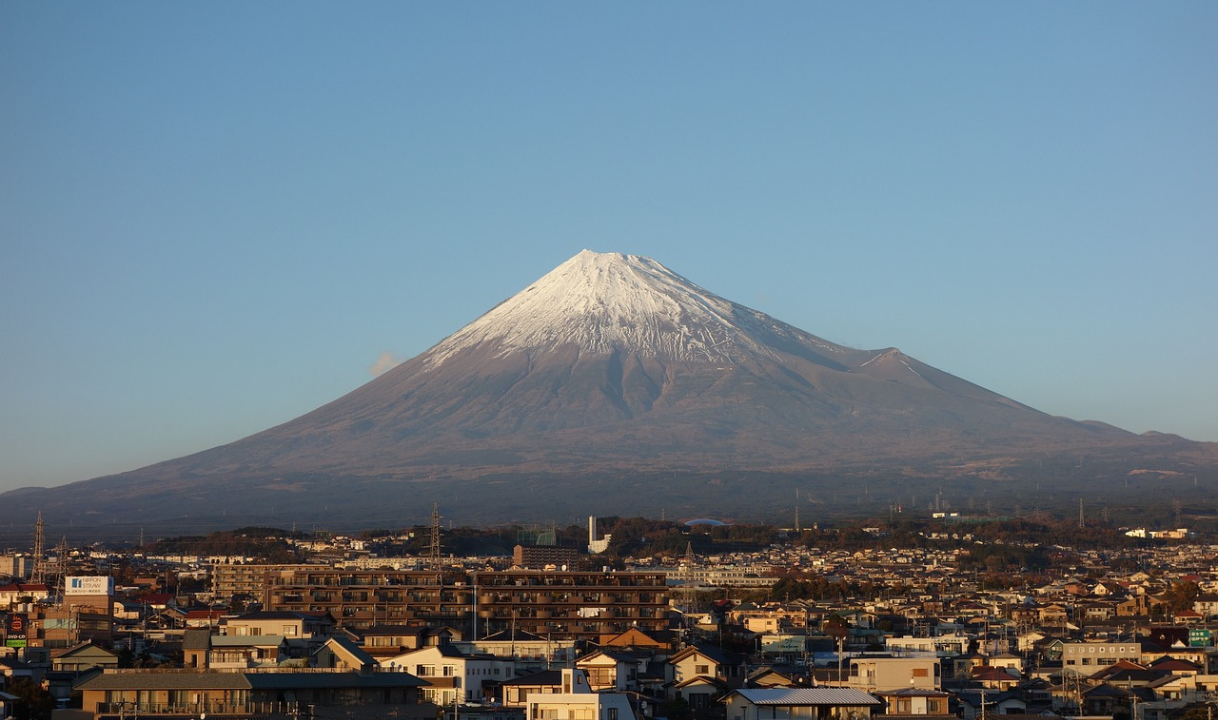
0,508 -> 1218,720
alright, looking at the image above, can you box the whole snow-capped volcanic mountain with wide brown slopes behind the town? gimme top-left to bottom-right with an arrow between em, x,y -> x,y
0,251 -> 1218,526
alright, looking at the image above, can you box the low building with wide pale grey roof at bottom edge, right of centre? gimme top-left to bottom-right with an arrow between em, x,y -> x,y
722,687 -> 881,720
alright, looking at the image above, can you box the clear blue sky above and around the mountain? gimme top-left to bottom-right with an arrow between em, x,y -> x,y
0,0 -> 1218,490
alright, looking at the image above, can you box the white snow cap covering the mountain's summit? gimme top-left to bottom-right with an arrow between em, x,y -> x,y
418,250 -> 845,368
